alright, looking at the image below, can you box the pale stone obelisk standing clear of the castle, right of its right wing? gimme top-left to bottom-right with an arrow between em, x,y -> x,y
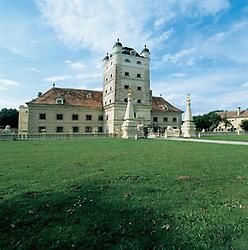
181,94 -> 196,137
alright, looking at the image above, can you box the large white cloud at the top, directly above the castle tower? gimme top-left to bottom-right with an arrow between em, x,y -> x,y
37,0 -> 229,53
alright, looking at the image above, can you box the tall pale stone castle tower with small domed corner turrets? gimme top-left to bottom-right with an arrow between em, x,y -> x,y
103,39 -> 152,134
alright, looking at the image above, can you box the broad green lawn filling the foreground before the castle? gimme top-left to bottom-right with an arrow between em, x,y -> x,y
0,139 -> 248,249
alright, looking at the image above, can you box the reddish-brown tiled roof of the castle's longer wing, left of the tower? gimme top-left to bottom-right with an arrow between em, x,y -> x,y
27,88 -> 102,108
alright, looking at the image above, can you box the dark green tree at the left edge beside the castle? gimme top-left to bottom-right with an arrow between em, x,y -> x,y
0,108 -> 19,128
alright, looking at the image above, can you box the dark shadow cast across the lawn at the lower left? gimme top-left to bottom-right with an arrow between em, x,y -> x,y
0,180 -> 241,249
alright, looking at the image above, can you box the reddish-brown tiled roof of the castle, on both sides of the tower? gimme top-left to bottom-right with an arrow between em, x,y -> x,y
27,88 -> 182,112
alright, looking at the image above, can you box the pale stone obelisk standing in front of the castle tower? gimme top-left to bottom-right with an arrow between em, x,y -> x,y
121,92 -> 137,139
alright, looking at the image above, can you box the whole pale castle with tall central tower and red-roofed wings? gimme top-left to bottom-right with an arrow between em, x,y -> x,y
19,39 -> 182,134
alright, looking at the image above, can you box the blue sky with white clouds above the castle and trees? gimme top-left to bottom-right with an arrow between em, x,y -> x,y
0,0 -> 248,114
